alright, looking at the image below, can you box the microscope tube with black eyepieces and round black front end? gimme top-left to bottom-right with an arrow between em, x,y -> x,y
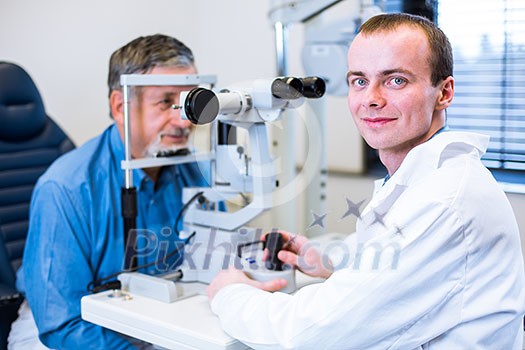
182,77 -> 326,125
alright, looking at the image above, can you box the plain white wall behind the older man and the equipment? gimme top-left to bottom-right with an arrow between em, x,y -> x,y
0,0 -> 362,172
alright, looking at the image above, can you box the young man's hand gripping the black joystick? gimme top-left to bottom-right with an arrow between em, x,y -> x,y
262,231 -> 334,278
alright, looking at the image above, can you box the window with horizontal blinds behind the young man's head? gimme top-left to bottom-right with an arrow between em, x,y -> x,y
437,0 -> 525,172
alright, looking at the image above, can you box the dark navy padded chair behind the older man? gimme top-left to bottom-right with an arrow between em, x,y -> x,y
0,62 -> 75,349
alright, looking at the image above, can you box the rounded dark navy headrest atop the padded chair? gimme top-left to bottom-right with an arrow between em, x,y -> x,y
0,62 -> 46,141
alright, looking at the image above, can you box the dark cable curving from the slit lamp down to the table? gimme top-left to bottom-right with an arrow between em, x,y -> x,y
87,191 -> 204,293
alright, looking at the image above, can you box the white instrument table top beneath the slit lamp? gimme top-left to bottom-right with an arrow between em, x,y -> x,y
81,284 -> 248,350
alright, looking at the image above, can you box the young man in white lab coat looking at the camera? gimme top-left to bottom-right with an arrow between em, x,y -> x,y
208,14 -> 525,350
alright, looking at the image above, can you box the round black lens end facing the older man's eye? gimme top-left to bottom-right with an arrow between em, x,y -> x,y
184,88 -> 220,125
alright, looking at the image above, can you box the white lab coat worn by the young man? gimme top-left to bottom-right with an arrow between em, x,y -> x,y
211,131 -> 525,350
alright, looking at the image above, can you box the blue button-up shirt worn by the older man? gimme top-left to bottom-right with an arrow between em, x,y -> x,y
17,125 -> 209,349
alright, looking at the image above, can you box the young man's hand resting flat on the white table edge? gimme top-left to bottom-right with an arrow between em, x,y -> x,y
206,267 -> 287,302
